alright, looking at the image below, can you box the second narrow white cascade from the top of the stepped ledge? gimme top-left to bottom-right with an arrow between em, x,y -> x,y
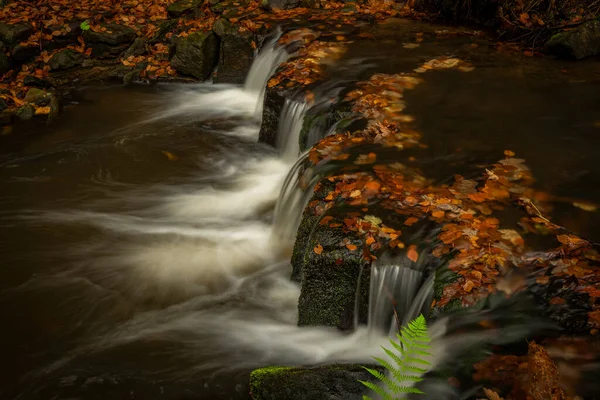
277,99 -> 308,163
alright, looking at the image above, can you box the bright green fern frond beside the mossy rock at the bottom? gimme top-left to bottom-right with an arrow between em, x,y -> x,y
359,315 -> 431,400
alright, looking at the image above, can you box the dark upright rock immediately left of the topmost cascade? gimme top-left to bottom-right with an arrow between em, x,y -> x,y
213,19 -> 254,83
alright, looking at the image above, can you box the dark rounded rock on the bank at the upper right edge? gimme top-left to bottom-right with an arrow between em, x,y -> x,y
545,19 -> 600,59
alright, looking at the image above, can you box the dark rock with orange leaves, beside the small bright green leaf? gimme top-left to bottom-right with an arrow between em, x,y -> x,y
83,24 -> 137,57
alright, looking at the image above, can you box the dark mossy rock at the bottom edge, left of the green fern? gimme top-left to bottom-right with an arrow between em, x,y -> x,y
250,364 -> 382,400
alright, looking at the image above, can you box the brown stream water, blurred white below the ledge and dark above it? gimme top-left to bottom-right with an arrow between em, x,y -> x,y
0,21 -> 600,400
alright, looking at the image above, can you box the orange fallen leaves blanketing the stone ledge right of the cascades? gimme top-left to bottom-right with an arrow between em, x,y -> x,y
308,54 -> 600,335
